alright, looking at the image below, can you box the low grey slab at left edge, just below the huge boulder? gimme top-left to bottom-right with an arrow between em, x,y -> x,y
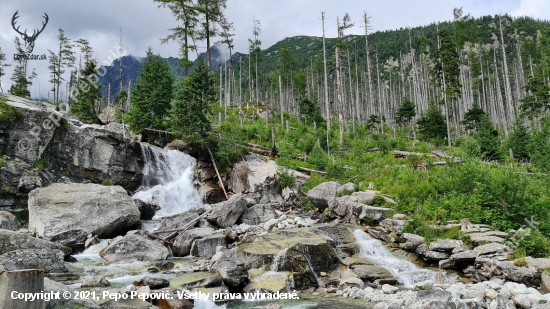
0,229 -> 71,256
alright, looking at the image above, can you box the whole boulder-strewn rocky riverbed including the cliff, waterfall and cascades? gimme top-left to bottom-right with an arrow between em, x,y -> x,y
0,96 -> 550,309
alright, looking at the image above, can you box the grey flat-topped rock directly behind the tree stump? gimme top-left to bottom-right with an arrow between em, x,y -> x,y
0,249 -> 67,273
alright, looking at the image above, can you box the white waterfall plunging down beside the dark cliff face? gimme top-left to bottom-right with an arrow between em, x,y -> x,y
133,144 -> 202,217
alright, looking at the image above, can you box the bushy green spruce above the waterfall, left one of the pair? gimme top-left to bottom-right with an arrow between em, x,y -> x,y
125,47 -> 173,134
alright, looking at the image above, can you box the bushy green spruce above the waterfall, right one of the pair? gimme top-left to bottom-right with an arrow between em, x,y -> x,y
170,57 -> 216,143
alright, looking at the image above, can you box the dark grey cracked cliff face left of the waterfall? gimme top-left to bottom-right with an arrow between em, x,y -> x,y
0,93 -> 143,211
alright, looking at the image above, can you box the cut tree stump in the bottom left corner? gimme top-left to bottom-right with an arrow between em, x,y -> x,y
0,269 -> 45,309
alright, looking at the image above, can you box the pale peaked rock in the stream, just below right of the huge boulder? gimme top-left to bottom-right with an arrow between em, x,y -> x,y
99,231 -> 169,262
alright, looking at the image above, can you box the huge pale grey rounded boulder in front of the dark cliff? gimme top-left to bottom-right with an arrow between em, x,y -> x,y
29,183 -> 140,246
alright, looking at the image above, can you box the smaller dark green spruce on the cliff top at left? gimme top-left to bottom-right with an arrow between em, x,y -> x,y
69,59 -> 101,123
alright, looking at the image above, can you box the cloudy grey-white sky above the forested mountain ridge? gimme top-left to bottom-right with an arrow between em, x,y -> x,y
0,0 -> 550,97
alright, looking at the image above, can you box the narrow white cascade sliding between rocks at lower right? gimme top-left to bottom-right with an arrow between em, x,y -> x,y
353,229 -> 448,287
